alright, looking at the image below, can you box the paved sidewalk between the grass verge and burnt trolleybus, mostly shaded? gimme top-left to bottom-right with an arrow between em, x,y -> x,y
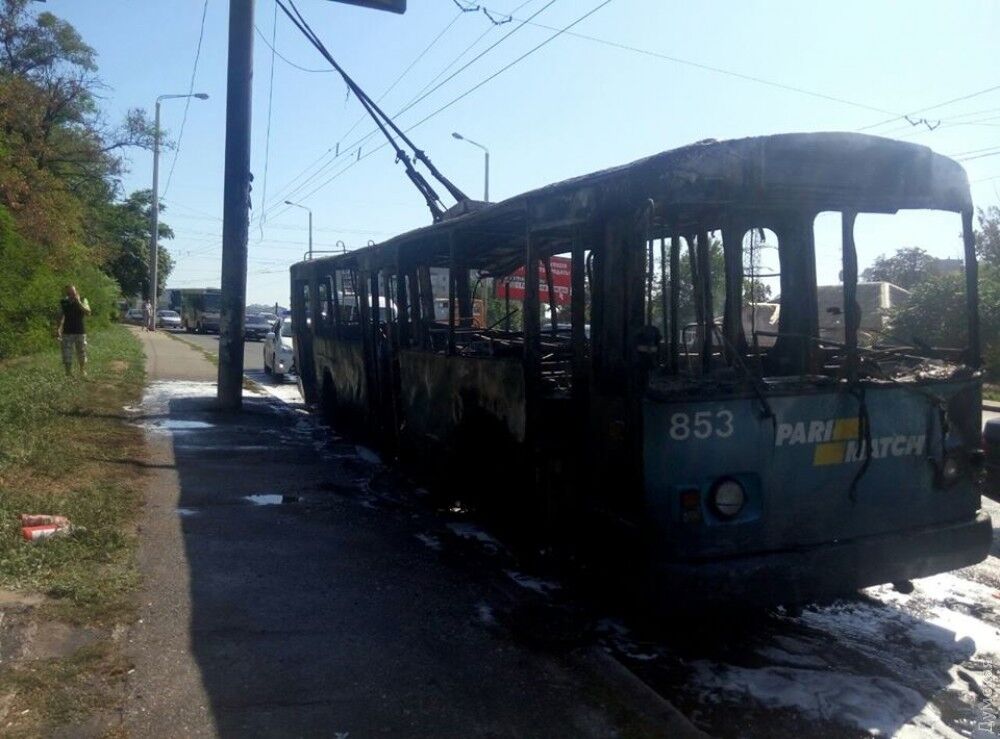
126,334 -> 685,739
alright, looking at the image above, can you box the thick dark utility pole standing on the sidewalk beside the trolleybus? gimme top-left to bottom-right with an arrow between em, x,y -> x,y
218,0 -> 253,410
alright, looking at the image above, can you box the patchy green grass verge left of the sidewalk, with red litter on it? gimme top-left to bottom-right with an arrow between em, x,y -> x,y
0,326 -> 144,735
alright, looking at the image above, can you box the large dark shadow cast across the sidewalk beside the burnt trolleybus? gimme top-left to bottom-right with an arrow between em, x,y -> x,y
169,397 -> 616,737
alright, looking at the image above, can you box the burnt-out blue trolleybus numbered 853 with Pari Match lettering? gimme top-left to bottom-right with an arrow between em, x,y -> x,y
291,133 -> 992,602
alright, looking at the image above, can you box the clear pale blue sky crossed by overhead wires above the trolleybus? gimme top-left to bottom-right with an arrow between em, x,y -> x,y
45,0 -> 1000,303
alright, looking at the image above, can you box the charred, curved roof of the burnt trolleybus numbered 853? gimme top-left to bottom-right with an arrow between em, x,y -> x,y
293,133 -> 972,273
